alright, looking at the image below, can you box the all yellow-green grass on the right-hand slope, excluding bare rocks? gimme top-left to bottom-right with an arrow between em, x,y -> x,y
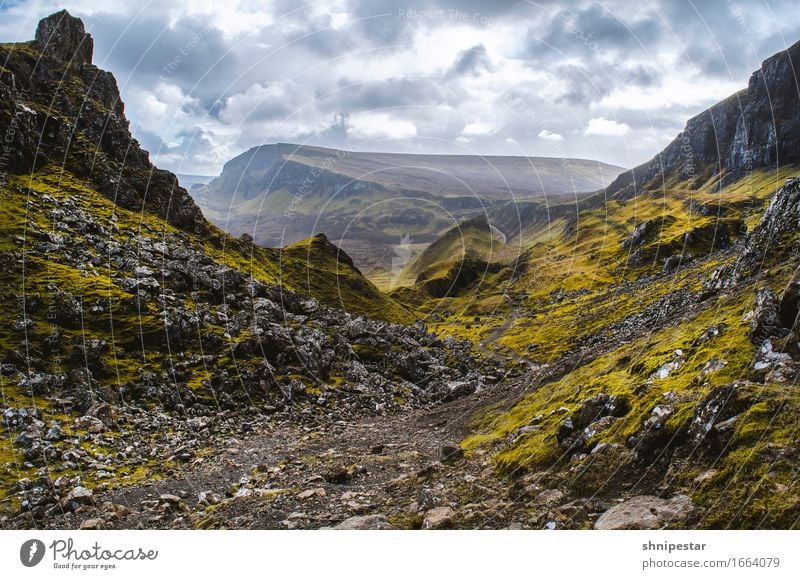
412,167 -> 800,527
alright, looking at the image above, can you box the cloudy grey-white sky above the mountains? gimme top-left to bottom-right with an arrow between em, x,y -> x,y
0,0 -> 800,175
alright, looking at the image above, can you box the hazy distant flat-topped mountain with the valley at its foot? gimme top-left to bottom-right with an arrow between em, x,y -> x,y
192,144 -> 622,279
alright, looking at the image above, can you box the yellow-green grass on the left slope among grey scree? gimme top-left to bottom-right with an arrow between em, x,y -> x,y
0,169 -> 414,498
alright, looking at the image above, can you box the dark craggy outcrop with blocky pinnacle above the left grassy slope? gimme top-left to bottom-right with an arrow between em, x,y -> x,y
0,11 -> 208,232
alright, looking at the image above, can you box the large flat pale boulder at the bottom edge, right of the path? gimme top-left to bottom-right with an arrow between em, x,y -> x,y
594,495 -> 693,531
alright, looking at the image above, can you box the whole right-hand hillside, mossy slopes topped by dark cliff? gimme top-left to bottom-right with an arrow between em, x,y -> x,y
404,37 -> 800,528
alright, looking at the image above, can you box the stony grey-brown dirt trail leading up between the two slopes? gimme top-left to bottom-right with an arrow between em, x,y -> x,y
36,372 -> 536,529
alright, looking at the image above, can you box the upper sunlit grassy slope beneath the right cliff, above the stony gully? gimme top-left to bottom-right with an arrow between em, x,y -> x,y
421,167 -> 800,363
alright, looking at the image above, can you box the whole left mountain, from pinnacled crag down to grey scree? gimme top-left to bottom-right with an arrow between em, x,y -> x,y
0,11 -> 500,528
